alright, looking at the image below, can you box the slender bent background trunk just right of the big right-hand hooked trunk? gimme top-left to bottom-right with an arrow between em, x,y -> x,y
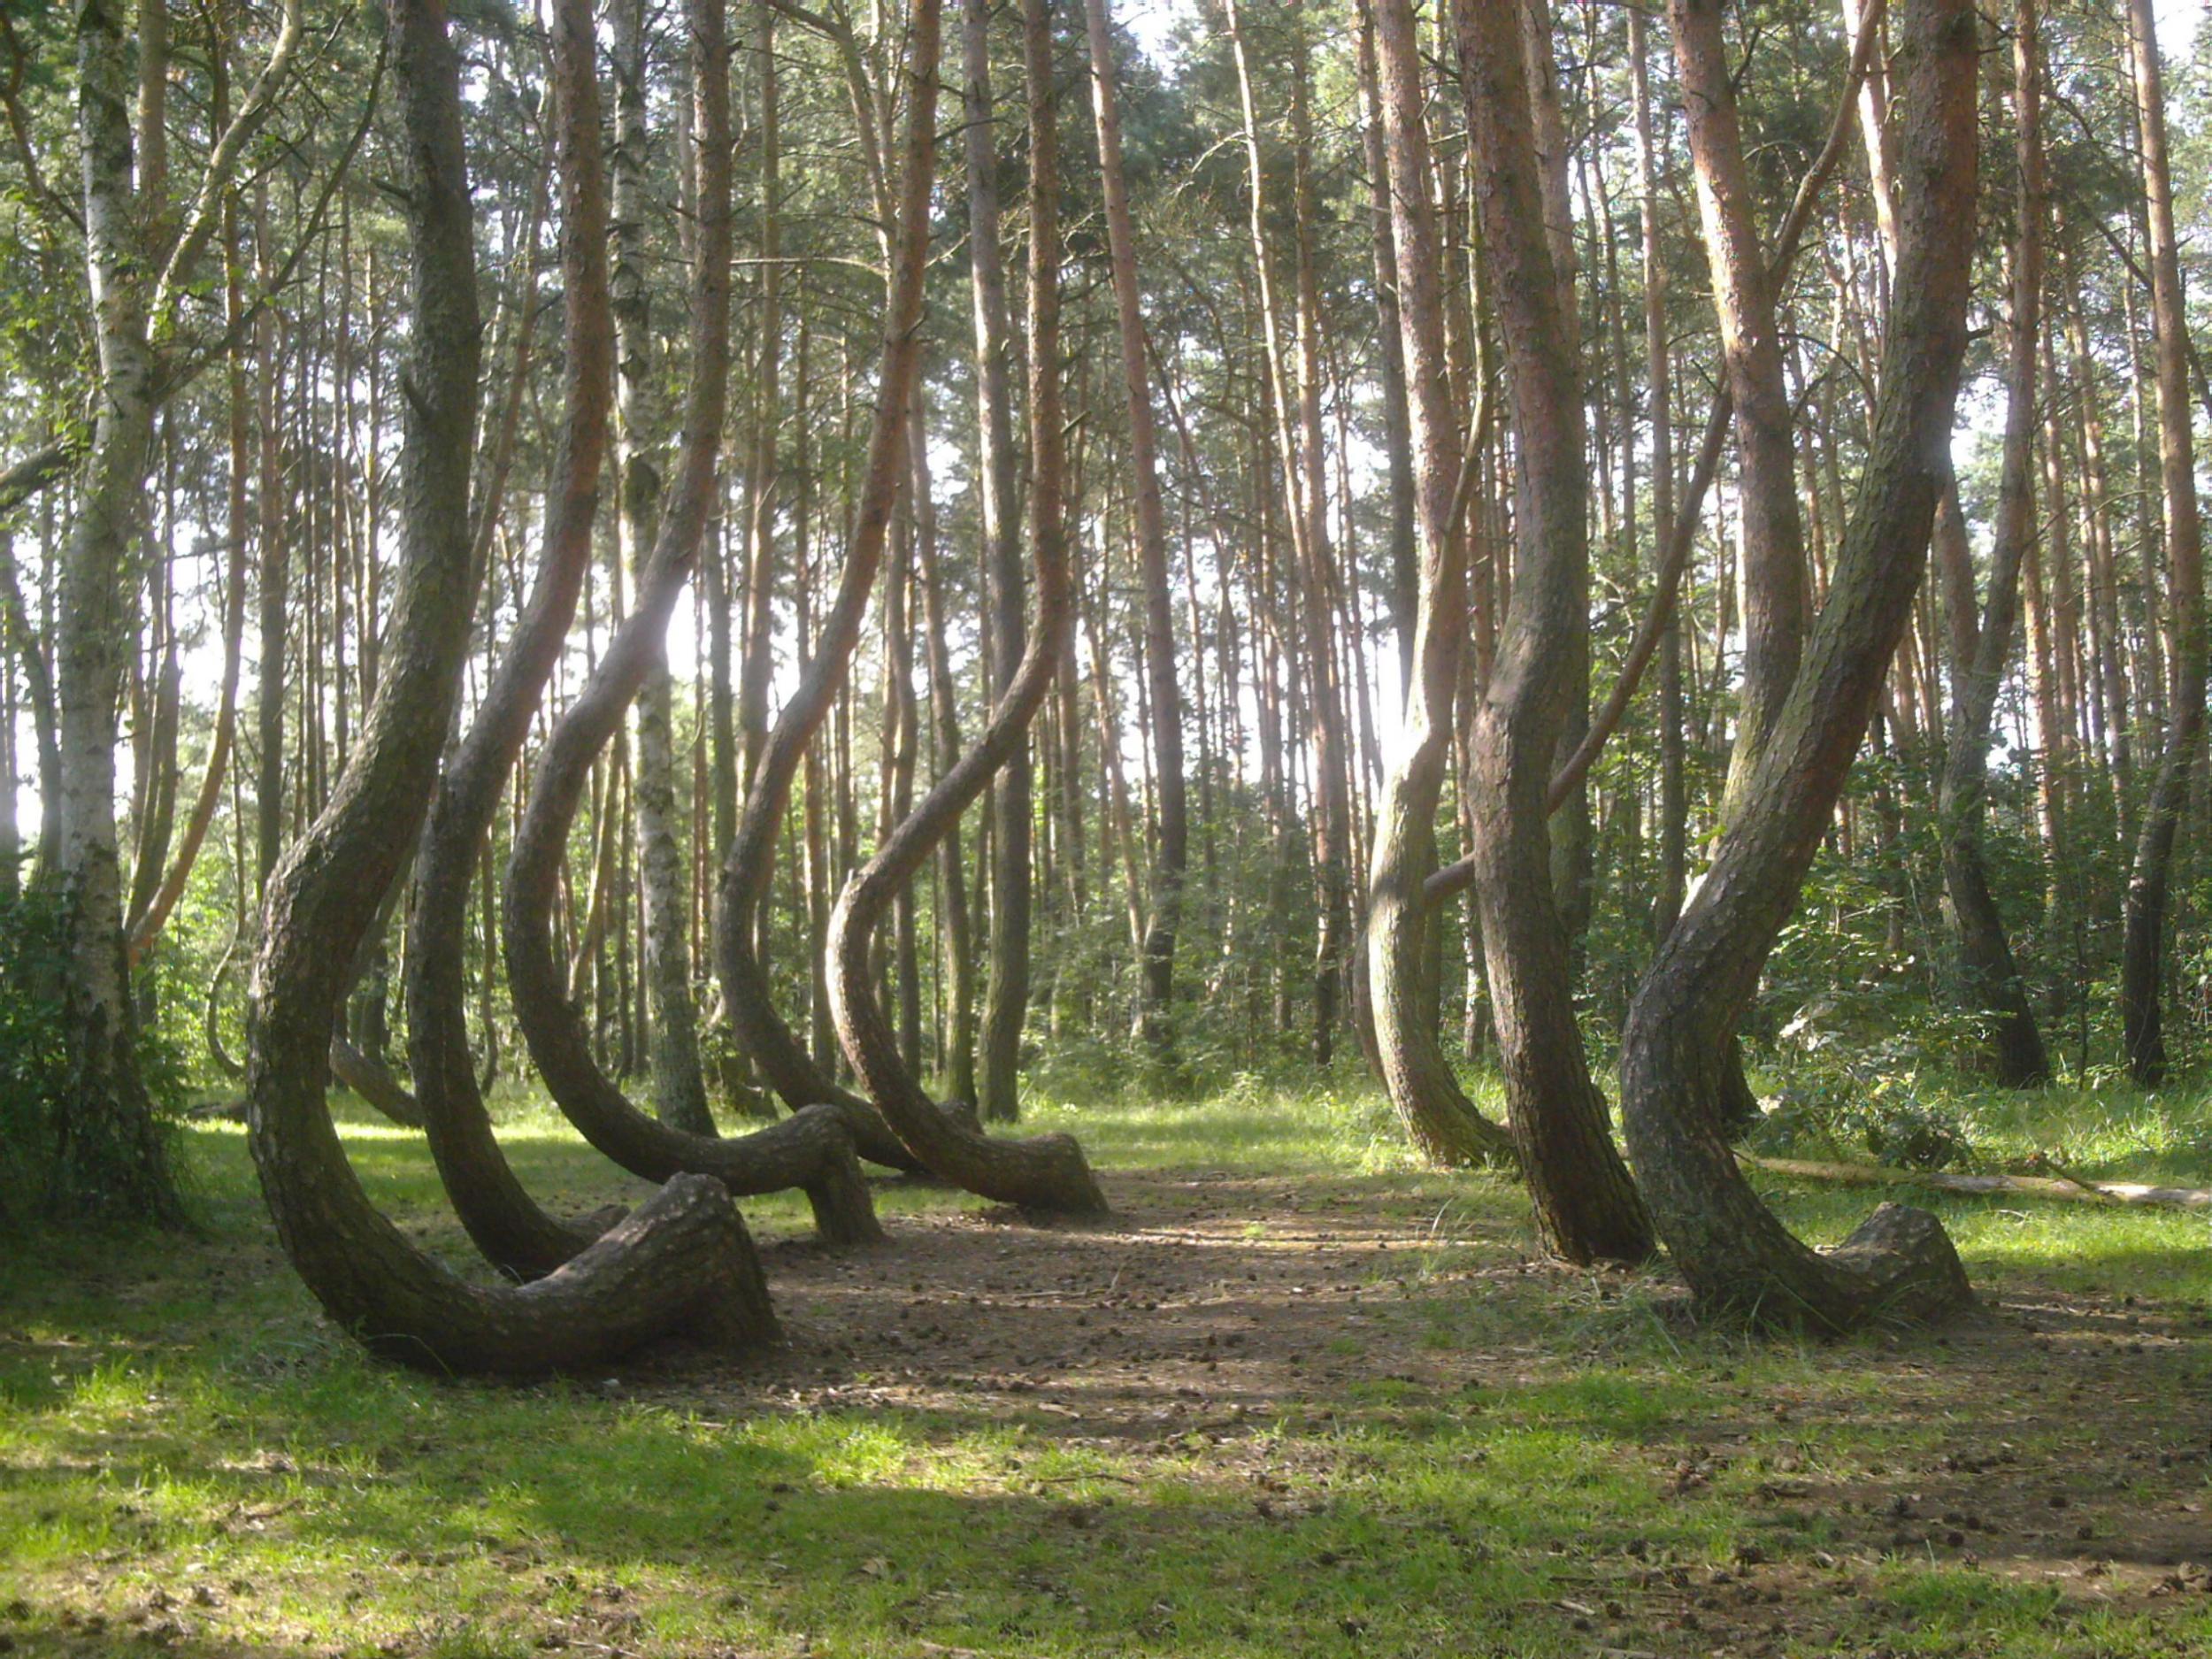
1938,0 -> 2051,1088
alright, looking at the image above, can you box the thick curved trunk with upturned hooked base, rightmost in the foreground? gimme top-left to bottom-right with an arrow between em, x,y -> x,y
1622,0 -> 1978,1330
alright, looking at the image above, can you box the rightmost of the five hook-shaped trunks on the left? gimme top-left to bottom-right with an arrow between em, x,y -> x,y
827,0 -> 1106,1215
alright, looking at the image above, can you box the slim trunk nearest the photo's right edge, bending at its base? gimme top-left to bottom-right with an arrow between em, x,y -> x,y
2119,0 -> 2206,1087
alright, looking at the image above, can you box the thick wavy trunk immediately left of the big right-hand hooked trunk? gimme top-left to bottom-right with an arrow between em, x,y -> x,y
1458,0 -> 1655,1261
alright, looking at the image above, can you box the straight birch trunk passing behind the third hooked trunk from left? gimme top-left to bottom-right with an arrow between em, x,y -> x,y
613,0 -> 717,1135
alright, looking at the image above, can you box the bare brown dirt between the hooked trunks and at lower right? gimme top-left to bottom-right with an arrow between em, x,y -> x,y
690,1172 -> 2212,1655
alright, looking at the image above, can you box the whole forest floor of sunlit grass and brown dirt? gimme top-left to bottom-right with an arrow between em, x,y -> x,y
0,1088 -> 2212,1659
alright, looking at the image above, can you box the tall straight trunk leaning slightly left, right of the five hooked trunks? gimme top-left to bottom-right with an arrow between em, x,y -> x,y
1084,0 -> 1190,1060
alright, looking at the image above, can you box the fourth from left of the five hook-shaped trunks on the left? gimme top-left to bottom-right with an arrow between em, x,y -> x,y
715,7 -> 938,1171
